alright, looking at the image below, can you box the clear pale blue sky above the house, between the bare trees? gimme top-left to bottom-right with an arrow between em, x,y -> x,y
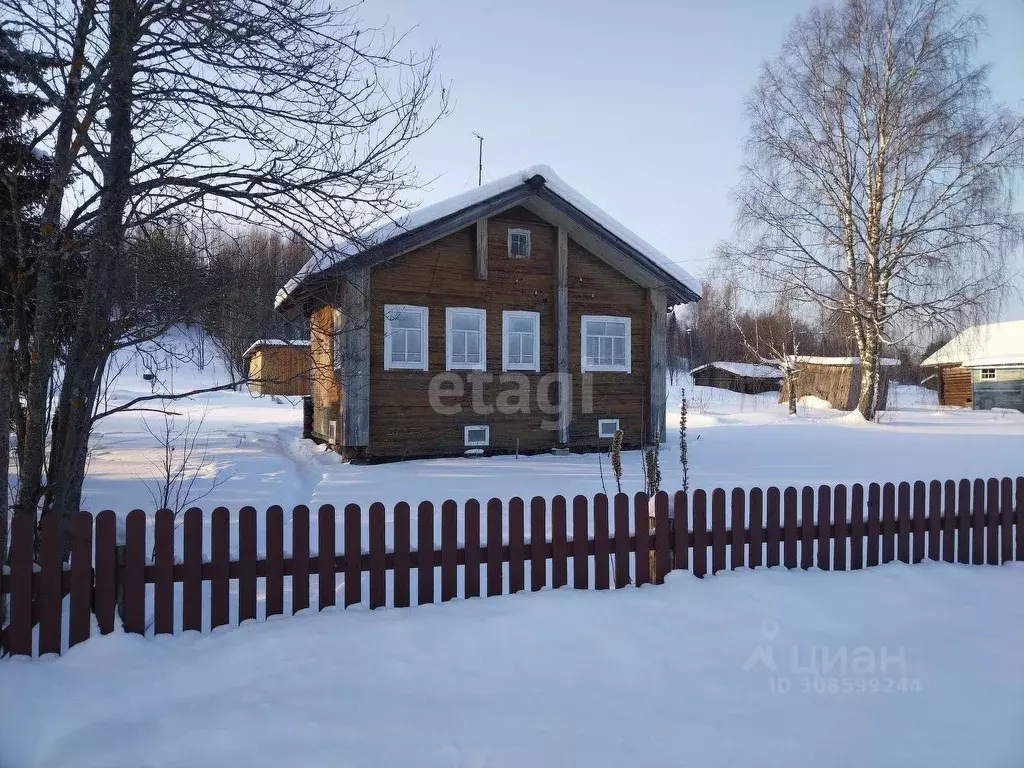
359,0 -> 1024,317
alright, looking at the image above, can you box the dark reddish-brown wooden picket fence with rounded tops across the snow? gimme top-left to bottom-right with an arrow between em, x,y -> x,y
0,477 -> 1024,655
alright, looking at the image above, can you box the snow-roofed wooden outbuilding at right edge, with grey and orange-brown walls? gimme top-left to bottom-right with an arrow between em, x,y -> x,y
921,321 -> 1024,408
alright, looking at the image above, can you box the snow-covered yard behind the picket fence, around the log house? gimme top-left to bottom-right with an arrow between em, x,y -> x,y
75,333 -> 1024,520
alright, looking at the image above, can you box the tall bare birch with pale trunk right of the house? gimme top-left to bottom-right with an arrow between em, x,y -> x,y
723,0 -> 1024,418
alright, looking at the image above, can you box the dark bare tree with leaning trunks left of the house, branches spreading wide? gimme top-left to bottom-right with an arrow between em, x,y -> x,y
0,0 -> 445,552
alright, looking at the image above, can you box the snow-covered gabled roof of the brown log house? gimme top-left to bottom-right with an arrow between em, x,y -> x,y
274,165 -> 700,307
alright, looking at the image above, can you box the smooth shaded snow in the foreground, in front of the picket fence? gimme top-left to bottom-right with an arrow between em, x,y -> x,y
0,563 -> 1024,768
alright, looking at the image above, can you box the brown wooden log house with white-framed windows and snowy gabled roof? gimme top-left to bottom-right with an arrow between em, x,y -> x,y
276,166 -> 699,461
